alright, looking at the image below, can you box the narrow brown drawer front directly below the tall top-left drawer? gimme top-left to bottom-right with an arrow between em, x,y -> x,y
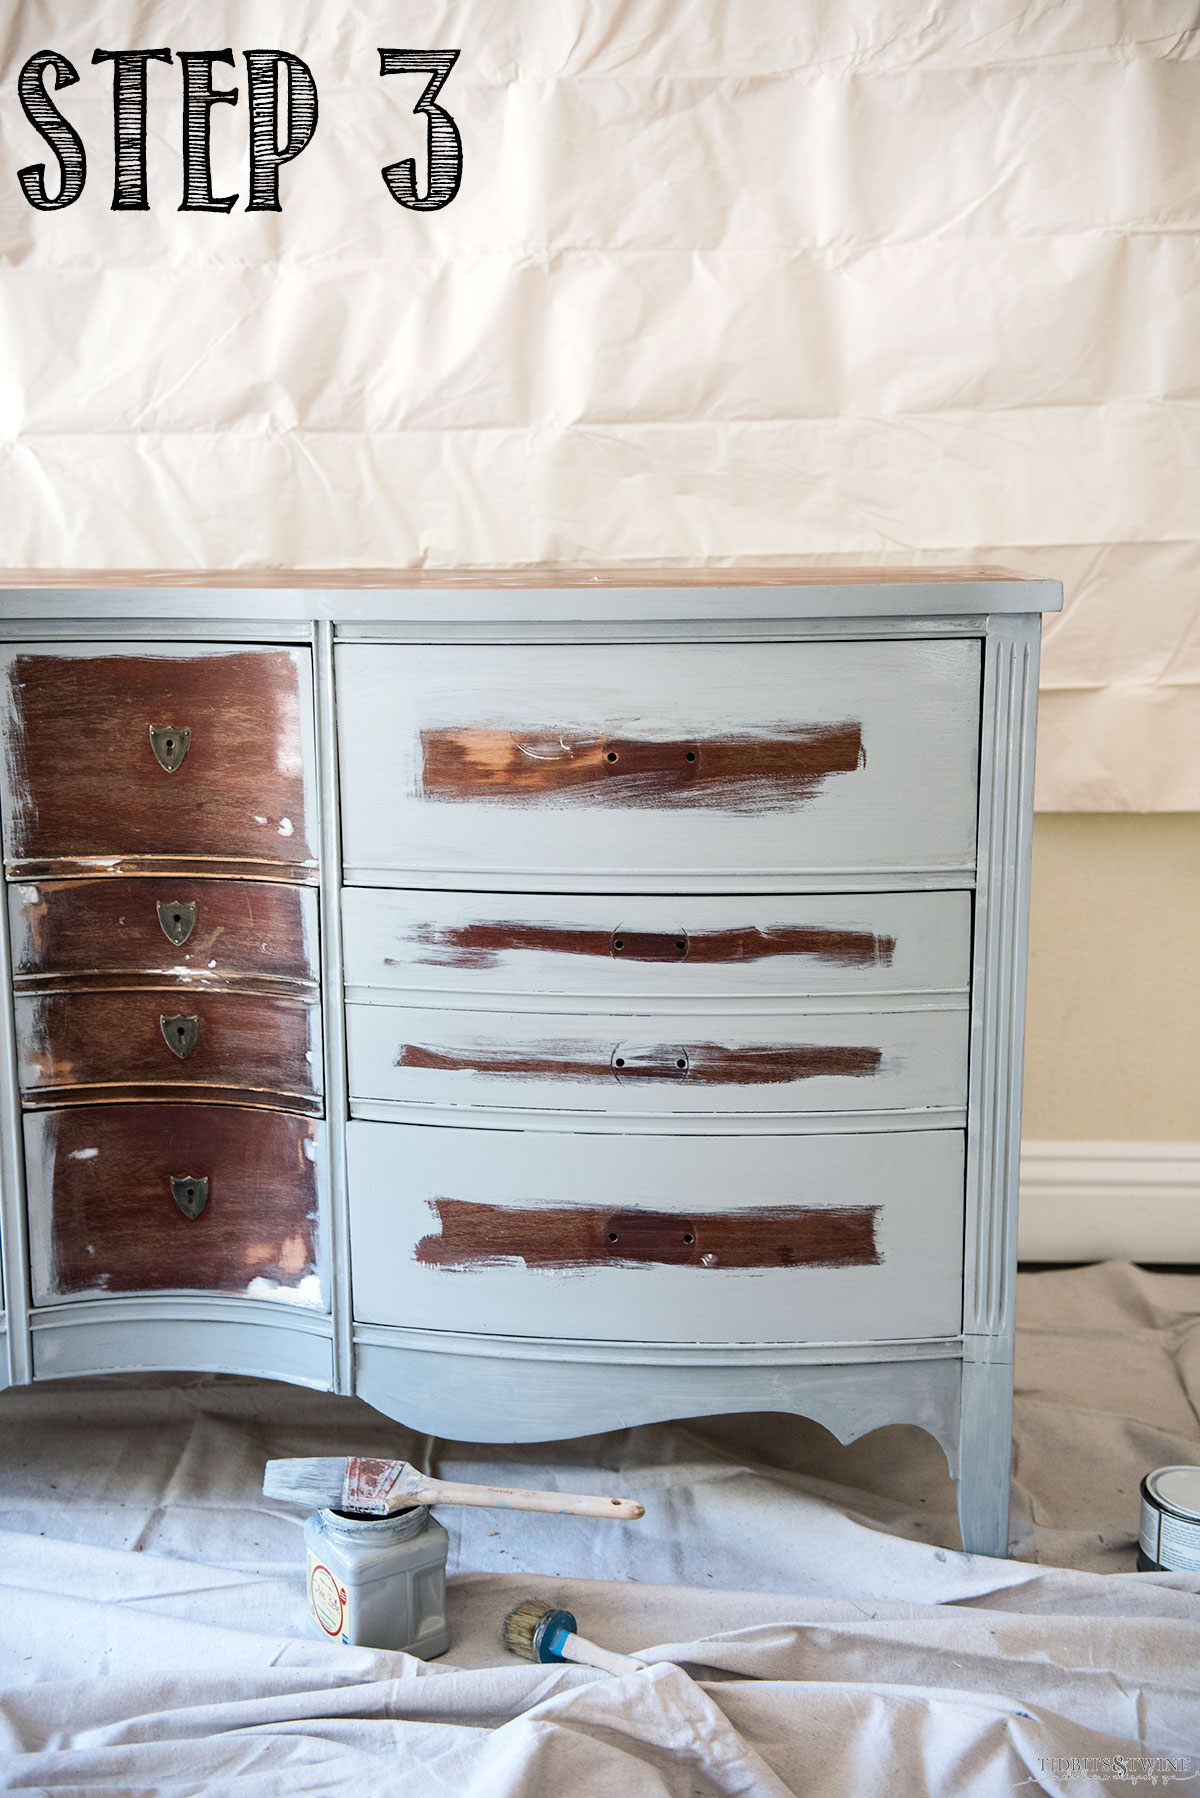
9,876 -> 318,985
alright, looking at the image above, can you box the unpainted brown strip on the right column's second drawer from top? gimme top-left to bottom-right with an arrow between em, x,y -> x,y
408,922 -> 896,967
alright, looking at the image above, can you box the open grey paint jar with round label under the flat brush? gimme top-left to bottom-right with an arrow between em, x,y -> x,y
304,1505 -> 450,1661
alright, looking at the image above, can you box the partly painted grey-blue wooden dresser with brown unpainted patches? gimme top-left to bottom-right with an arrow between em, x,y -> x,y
0,570 -> 1061,1553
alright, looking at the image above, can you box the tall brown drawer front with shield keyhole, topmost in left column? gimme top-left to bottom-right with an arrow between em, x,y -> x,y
0,645 -> 315,877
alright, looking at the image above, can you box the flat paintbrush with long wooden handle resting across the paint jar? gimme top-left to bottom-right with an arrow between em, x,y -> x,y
263,1455 -> 644,1519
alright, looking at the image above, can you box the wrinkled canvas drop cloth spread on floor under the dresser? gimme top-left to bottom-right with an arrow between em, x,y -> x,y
0,1264 -> 1200,1798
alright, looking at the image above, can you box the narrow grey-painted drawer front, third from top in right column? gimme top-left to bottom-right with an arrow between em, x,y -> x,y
347,1000 -> 968,1120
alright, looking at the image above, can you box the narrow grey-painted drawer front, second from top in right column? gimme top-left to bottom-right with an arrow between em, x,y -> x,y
342,886 -> 972,1005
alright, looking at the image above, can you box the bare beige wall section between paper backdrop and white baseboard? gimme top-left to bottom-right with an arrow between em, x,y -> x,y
1024,813 -> 1200,1142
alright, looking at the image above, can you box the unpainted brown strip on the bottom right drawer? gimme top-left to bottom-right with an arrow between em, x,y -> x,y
414,1197 -> 880,1271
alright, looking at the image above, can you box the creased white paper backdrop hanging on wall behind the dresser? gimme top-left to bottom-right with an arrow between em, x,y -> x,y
0,0 -> 1200,809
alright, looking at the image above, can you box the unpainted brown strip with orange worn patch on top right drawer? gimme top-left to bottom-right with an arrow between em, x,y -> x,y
421,723 -> 865,811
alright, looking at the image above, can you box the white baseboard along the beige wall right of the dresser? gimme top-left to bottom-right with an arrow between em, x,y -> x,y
1018,1142 -> 1200,1262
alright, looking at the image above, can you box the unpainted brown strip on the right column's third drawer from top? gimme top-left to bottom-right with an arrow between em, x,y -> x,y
396,1043 -> 883,1086
